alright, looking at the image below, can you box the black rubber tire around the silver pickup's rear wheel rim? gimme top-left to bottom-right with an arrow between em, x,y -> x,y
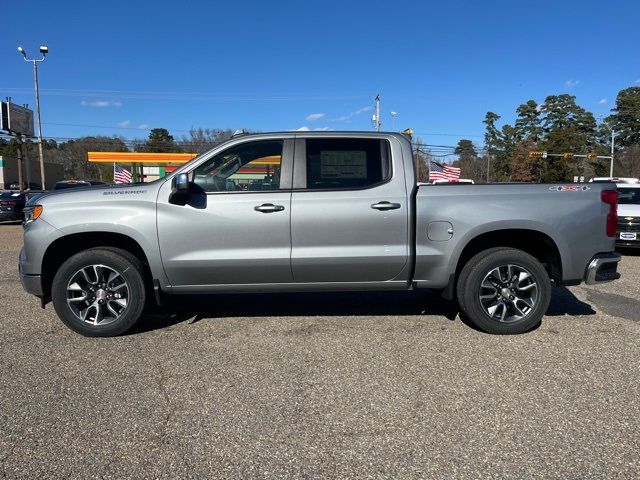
457,247 -> 551,335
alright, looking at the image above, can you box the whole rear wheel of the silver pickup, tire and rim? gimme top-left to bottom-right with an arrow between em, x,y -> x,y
457,247 -> 551,335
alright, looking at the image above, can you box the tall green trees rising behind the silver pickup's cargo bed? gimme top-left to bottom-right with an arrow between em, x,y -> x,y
454,87 -> 640,182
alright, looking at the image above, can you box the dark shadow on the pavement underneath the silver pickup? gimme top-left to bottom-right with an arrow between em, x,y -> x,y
130,287 -> 596,334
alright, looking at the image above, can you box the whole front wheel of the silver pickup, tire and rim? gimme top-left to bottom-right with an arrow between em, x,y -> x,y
51,248 -> 145,337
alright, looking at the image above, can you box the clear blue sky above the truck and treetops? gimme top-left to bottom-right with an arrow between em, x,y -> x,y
0,0 -> 640,145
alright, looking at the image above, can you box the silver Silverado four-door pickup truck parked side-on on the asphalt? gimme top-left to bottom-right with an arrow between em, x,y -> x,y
19,132 -> 620,336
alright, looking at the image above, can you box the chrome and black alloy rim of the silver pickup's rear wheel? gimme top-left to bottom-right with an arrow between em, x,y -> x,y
479,264 -> 538,323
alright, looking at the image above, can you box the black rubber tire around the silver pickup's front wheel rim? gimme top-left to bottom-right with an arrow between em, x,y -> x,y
51,247 -> 146,337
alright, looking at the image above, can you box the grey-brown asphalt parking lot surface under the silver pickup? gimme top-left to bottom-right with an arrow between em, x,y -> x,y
0,225 -> 640,479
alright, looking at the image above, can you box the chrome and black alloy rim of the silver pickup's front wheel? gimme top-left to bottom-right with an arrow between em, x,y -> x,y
67,265 -> 129,326
